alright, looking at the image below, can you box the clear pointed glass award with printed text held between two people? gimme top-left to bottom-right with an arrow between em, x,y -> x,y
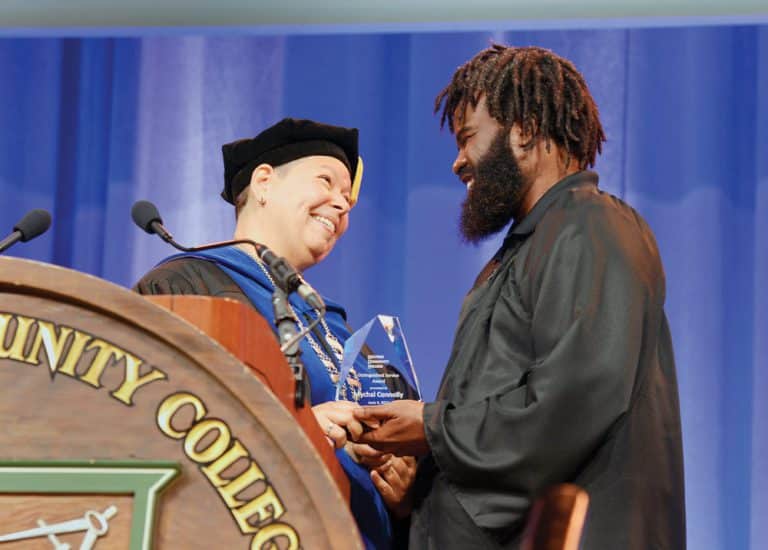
336,315 -> 421,405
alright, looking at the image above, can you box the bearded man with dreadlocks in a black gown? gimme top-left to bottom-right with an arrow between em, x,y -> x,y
356,45 -> 685,550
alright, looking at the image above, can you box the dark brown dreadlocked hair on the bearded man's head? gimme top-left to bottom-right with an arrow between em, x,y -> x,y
435,44 -> 605,169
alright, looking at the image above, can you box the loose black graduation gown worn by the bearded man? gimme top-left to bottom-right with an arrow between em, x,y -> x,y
410,172 -> 685,550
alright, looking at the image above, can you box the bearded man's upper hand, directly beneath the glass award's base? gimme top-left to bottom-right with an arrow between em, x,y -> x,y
354,399 -> 429,456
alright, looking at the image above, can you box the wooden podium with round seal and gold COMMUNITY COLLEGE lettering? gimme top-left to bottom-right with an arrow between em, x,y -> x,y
0,258 -> 362,550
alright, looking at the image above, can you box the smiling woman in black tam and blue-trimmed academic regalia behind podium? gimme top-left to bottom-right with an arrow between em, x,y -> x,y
135,119 -> 415,550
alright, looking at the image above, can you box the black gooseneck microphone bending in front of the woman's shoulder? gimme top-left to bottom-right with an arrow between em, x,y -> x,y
131,201 -> 325,312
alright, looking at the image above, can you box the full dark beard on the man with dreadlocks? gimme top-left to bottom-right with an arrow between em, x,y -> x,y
459,128 -> 528,244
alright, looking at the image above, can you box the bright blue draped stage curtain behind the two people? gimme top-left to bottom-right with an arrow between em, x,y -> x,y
0,26 -> 768,550
